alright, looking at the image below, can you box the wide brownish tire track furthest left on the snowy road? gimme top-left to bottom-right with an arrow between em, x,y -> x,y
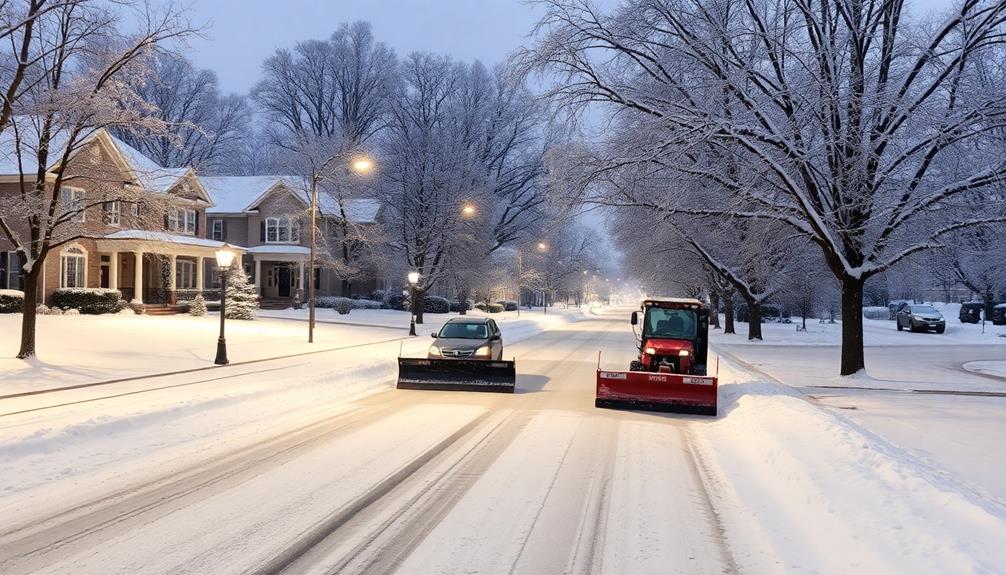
0,406 -> 394,573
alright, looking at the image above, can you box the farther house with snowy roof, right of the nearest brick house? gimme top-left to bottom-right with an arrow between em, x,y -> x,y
201,176 -> 381,304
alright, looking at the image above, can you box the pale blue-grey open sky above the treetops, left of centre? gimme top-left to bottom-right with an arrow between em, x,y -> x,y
177,0 -> 541,92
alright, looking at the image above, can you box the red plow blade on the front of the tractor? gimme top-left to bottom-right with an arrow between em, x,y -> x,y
594,369 -> 718,415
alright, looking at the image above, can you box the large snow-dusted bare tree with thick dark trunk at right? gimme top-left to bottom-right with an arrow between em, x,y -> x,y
521,0 -> 1006,375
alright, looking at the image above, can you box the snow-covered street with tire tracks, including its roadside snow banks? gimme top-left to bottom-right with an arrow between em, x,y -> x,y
0,310 -> 1006,575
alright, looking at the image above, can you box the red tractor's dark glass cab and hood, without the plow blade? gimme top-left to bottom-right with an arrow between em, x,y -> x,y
629,299 -> 709,375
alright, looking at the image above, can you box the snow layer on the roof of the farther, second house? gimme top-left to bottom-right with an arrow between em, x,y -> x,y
199,176 -> 380,223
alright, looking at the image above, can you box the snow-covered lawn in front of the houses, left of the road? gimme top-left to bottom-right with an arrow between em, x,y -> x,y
0,310 -> 580,396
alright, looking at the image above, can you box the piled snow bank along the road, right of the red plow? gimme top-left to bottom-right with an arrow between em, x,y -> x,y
691,363 -> 1006,573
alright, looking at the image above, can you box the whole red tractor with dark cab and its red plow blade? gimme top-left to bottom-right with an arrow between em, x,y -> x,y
595,299 -> 717,415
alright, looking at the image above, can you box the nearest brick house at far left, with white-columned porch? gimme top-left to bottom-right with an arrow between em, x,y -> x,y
0,130 -> 243,305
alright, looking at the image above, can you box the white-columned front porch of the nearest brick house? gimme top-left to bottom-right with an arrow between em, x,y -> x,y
96,232 -> 244,305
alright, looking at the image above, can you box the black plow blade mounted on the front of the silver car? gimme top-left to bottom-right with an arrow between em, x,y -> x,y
397,358 -> 517,393
